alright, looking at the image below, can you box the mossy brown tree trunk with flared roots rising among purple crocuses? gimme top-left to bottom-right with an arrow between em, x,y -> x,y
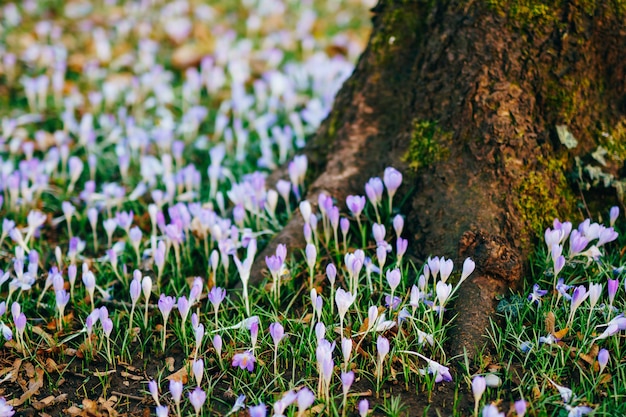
255,0 -> 626,355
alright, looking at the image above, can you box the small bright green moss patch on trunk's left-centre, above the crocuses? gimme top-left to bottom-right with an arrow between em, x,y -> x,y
403,121 -> 452,171
